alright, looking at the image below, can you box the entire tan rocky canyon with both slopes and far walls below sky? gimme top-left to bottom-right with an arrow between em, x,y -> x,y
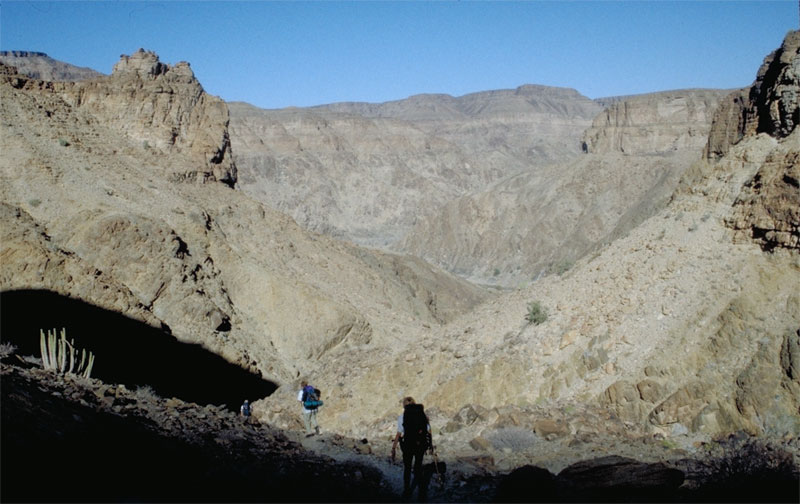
0,32 -> 800,501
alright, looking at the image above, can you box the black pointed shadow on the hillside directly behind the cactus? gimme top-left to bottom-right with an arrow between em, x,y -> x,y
0,290 -> 277,410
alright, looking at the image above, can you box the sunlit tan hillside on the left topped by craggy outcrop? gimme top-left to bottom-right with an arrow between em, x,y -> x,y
0,51 -> 485,390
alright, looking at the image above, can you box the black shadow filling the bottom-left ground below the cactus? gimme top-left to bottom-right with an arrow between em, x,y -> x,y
0,371 -> 391,502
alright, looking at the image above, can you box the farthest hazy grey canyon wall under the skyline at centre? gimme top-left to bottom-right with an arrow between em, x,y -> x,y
231,86 -> 600,247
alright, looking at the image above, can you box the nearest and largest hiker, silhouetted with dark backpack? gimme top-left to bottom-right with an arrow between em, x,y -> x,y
392,397 -> 433,499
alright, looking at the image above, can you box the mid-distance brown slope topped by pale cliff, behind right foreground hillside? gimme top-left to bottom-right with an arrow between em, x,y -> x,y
400,90 -> 724,287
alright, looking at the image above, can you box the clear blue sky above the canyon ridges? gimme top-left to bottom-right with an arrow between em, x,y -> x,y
0,0 -> 798,108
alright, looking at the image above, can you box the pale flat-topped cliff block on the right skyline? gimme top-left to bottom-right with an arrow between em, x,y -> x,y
583,89 -> 727,155
